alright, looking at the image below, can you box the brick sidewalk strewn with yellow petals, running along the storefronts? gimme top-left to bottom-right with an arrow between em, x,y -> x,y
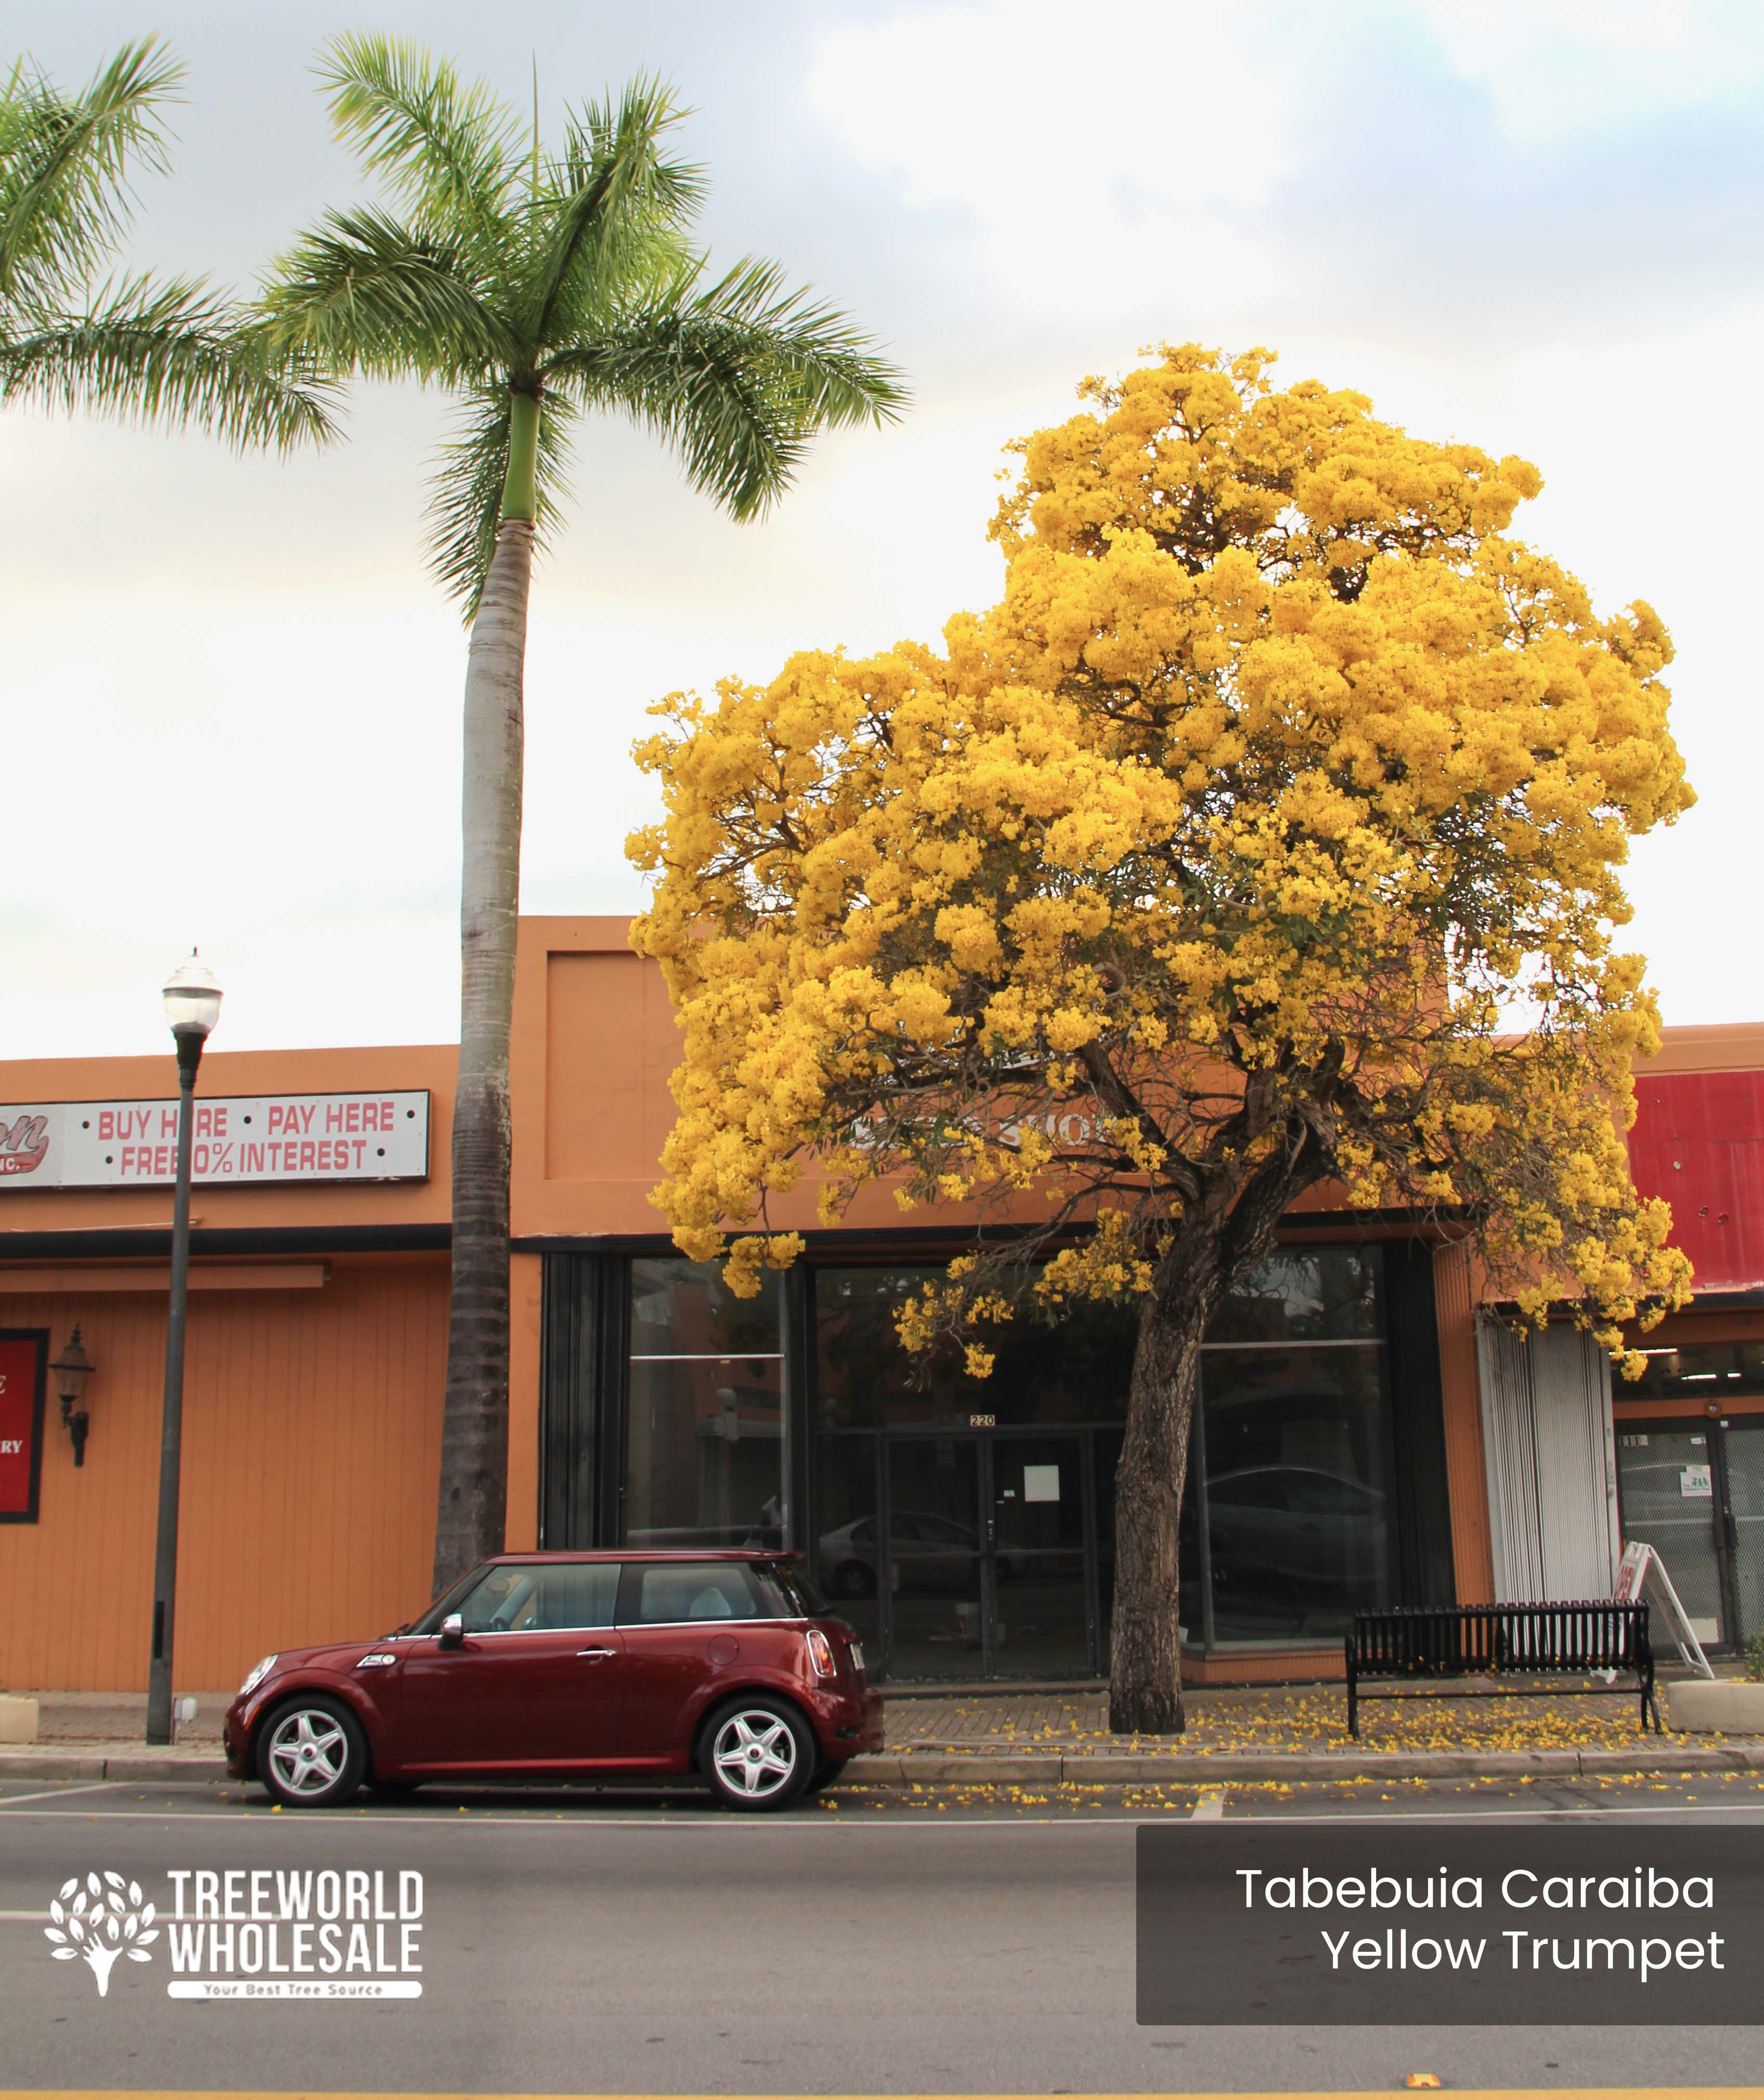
0,1684 -> 1764,1785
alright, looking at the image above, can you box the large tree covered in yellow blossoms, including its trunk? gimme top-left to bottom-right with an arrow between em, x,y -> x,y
630,344 -> 1691,1732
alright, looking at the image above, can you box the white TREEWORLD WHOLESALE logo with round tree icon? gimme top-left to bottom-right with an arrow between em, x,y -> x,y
44,1867 -> 422,1999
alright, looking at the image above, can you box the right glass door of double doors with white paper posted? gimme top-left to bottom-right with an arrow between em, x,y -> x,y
987,1434 -> 1096,1678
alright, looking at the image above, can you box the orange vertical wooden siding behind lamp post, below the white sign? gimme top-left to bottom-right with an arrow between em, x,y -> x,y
0,1256 -> 447,1693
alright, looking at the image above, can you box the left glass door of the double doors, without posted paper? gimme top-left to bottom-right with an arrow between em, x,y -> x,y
882,1436 -> 993,1678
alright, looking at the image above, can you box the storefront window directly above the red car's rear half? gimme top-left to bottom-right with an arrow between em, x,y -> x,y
624,1260 -> 789,1546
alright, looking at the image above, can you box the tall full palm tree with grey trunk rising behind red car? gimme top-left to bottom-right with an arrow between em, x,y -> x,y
267,36 -> 905,1590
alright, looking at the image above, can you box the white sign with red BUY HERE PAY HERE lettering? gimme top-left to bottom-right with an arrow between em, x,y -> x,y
0,1090 -> 429,1195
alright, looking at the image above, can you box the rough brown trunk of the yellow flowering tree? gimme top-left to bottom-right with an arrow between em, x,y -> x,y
1109,1250 -> 1218,1734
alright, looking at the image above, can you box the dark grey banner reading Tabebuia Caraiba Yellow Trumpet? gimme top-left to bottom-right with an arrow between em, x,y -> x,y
1136,1817 -> 1764,2027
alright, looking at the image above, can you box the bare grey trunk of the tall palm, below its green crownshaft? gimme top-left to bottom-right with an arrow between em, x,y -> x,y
435,516 -> 534,1594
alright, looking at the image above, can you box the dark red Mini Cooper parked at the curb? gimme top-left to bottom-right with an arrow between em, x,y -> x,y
225,1552 -> 882,1808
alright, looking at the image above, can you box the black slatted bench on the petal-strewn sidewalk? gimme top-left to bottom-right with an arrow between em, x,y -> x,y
1346,1598 -> 1659,1739
